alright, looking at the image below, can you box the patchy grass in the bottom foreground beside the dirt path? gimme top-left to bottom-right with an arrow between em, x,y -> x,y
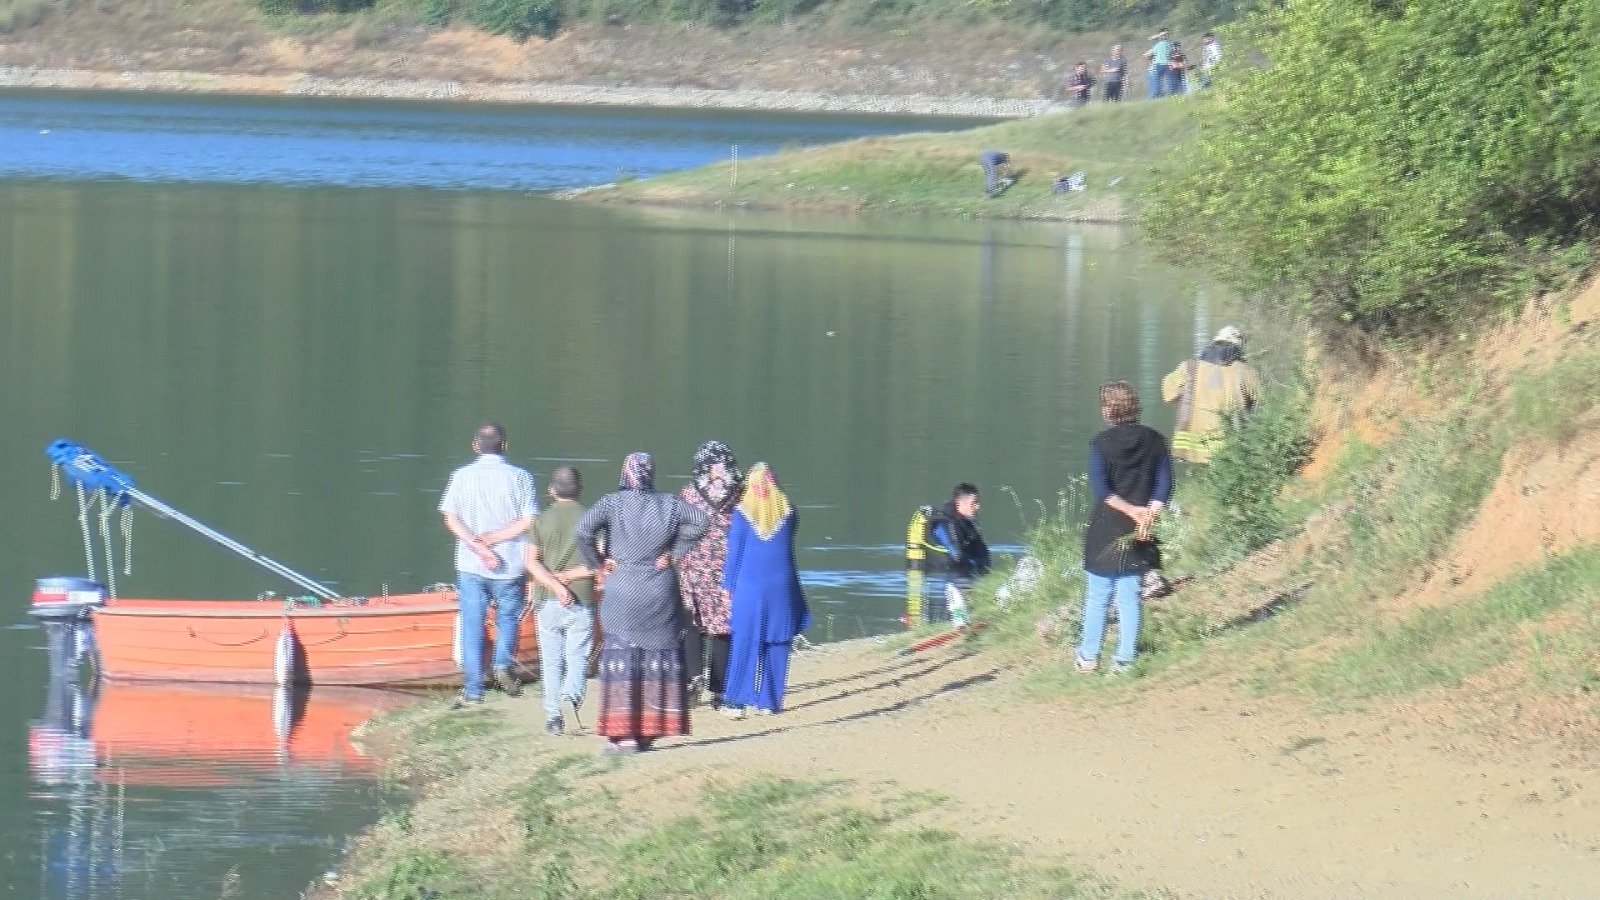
338,703 -> 1131,900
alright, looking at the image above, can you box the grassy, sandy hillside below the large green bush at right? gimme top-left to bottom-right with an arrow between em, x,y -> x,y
960,282 -> 1600,717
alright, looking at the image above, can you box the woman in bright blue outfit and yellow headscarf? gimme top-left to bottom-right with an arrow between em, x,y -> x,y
722,463 -> 811,719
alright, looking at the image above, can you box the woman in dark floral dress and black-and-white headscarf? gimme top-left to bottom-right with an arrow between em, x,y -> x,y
678,440 -> 744,706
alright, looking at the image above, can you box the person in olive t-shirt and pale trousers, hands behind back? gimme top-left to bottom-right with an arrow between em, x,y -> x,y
528,466 -> 595,735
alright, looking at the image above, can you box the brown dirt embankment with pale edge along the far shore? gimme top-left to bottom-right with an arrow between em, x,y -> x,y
0,0 -> 1134,117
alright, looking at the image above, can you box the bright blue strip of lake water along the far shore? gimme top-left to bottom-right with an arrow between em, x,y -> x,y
0,91 -> 979,191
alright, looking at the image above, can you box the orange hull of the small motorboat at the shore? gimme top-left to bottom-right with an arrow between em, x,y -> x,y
93,591 -> 538,685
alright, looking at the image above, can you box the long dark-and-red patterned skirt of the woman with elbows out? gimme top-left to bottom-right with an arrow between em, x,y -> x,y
595,636 -> 690,740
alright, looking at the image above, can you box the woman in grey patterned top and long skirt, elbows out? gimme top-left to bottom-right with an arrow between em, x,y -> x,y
578,453 -> 706,753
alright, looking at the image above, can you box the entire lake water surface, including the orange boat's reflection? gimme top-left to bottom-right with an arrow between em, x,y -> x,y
0,87 -> 1218,900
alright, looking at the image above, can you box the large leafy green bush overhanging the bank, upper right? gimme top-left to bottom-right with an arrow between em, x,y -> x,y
1147,0 -> 1600,333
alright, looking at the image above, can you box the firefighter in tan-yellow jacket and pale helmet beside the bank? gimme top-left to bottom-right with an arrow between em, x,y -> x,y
1162,325 -> 1261,463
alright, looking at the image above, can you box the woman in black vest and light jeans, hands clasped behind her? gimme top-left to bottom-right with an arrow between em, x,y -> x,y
1077,381 -> 1173,673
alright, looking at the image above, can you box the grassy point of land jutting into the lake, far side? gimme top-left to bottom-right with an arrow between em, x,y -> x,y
581,99 -> 1206,221
